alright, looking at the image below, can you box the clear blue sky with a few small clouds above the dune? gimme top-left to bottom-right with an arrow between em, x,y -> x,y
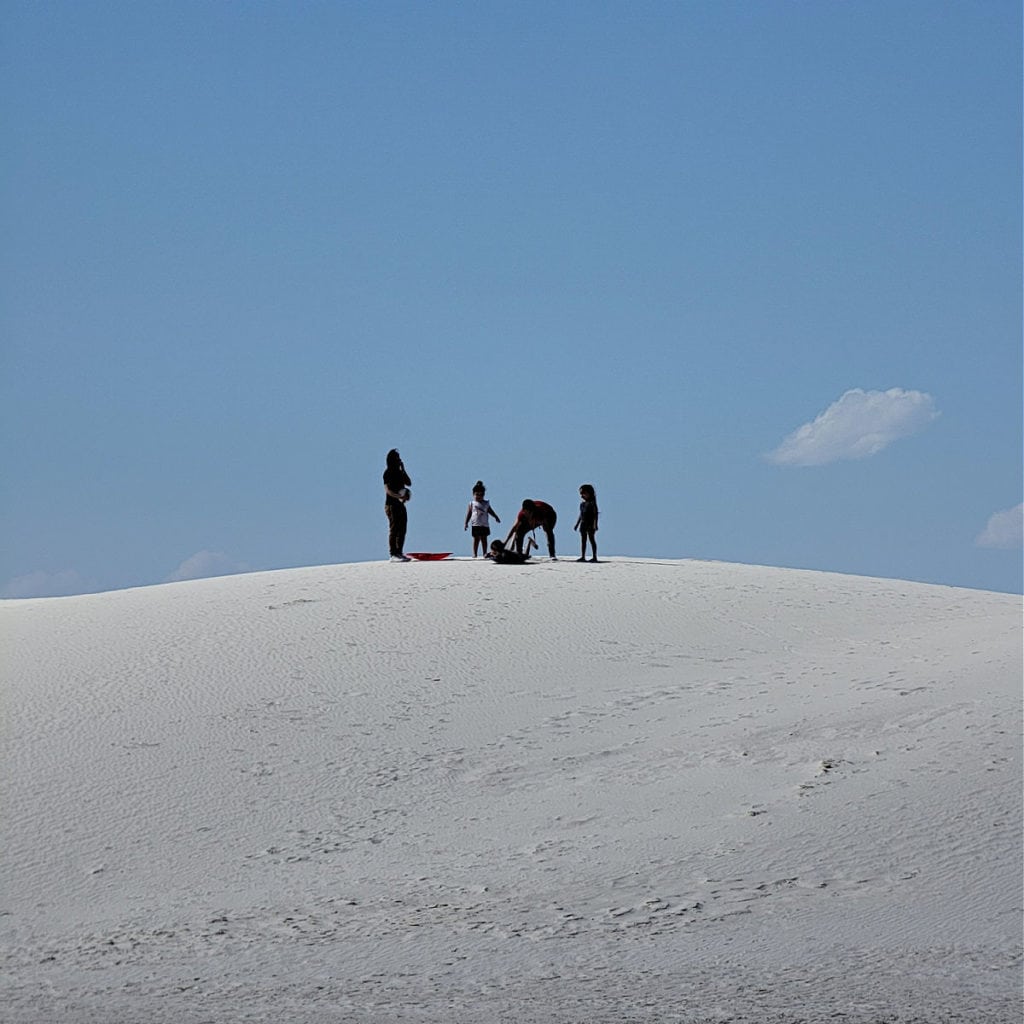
0,0 -> 1022,597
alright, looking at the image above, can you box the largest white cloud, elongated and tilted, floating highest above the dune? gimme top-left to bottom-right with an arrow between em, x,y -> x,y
766,387 -> 939,466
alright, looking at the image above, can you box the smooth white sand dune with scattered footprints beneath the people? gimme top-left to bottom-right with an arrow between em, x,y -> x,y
0,559 -> 1022,1024
